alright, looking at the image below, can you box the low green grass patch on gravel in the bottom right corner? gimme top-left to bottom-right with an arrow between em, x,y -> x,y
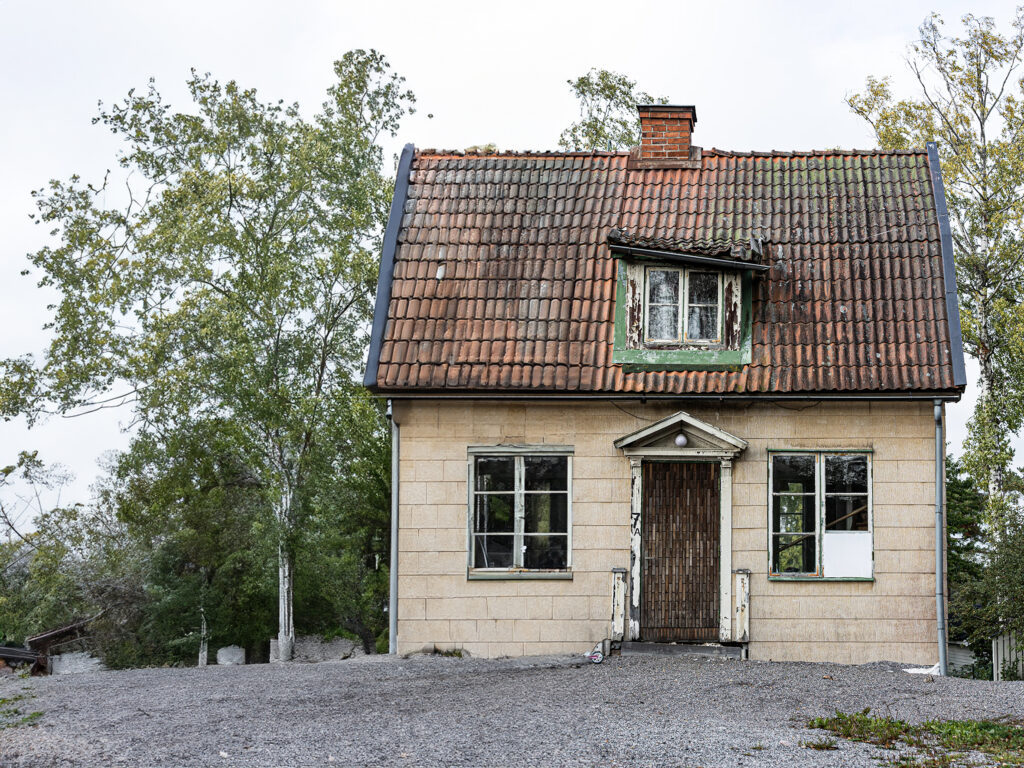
807,709 -> 1024,768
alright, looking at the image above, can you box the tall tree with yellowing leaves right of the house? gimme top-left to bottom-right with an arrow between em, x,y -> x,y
847,9 -> 1024,520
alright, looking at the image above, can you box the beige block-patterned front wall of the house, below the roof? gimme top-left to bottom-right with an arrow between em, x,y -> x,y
394,400 -> 937,664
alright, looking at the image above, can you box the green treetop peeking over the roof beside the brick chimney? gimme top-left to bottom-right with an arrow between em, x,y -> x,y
558,69 -> 668,152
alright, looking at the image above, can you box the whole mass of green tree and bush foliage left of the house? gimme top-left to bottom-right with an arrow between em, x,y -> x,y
0,50 -> 414,665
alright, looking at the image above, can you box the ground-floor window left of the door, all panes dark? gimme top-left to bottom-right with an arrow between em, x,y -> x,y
469,446 -> 572,571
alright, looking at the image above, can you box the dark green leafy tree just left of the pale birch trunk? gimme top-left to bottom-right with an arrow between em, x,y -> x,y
110,421 -> 274,662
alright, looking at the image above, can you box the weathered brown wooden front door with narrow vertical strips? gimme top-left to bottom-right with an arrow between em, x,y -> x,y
640,462 -> 720,642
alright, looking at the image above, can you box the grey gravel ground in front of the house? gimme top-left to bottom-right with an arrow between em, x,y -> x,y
0,656 -> 1024,768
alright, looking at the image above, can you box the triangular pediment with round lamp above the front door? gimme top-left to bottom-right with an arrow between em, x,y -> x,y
614,411 -> 746,459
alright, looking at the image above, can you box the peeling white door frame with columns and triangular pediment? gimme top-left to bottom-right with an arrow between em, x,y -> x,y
614,411 -> 746,642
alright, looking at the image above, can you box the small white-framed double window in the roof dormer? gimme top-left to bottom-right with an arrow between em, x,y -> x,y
644,266 -> 722,344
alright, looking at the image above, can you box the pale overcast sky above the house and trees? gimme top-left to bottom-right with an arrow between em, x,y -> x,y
0,0 -> 1020,501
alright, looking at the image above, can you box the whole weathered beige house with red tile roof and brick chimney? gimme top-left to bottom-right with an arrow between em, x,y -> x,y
365,105 -> 966,665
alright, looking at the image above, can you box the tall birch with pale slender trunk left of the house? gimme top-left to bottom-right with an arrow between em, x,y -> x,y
0,50 -> 414,659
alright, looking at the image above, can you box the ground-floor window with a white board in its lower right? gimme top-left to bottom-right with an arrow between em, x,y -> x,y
768,451 -> 873,579
